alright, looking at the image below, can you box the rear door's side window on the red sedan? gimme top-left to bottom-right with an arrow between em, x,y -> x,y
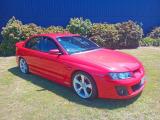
25,37 -> 41,50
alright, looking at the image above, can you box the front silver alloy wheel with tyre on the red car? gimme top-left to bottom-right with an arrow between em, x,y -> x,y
72,72 -> 97,99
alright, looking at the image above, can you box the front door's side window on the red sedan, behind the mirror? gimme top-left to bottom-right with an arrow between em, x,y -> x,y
39,37 -> 58,52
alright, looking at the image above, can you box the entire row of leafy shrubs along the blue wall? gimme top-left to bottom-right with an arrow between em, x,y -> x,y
0,17 -> 146,56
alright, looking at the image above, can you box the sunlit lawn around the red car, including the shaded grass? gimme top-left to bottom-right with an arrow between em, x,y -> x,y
0,47 -> 160,120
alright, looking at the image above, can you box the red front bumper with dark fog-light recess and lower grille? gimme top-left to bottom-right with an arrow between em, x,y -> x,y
94,75 -> 146,99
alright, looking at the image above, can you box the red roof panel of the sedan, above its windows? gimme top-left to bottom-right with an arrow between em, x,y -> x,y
34,32 -> 80,38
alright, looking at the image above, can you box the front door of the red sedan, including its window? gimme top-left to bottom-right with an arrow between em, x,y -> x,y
37,37 -> 65,83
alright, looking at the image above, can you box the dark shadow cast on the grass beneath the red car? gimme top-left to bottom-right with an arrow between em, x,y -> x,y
8,67 -> 141,110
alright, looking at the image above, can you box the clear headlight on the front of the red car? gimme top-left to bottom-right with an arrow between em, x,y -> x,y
109,72 -> 132,80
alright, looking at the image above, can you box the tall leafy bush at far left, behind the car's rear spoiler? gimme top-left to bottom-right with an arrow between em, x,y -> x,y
0,17 -> 23,55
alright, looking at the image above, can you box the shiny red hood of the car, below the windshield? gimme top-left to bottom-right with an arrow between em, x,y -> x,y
72,48 -> 140,72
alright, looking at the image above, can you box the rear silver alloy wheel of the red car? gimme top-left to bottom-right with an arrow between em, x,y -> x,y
19,58 -> 29,74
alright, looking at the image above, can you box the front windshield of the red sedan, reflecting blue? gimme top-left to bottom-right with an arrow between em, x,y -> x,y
57,36 -> 100,54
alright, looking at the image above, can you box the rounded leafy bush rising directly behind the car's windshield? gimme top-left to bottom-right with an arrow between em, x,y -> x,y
67,18 -> 92,36
